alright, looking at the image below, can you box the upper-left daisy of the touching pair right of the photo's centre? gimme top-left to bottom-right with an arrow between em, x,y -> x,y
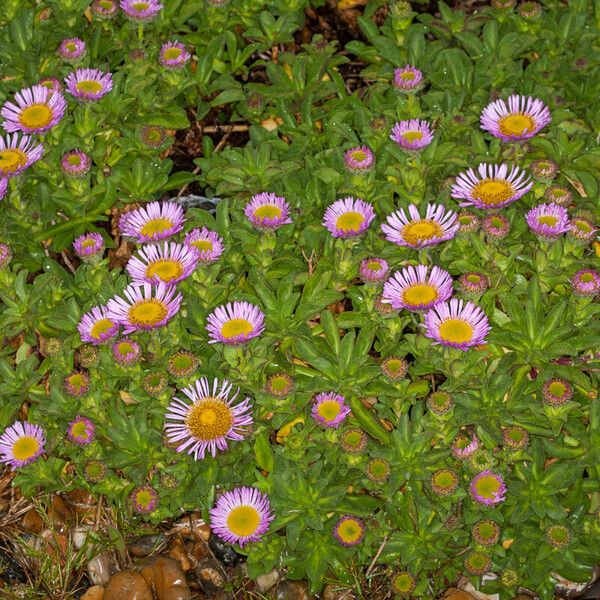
382,265 -> 452,311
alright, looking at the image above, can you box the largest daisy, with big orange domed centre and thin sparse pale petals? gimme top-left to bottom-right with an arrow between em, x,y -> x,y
165,377 -> 254,460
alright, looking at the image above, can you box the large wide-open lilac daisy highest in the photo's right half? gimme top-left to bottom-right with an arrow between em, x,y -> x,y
481,94 -> 552,142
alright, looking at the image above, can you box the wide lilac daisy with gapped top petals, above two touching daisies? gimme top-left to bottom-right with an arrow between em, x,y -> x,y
381,204 -> 460,248
